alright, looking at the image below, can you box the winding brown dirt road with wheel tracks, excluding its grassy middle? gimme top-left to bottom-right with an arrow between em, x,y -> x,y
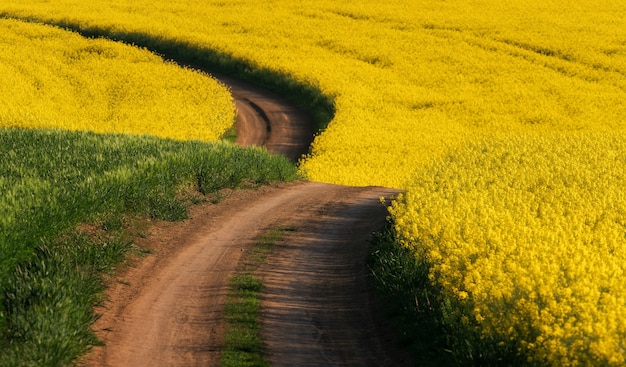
80,73 -> 408,367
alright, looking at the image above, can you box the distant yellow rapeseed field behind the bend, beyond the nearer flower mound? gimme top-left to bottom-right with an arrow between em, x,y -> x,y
0,0 -> 626,188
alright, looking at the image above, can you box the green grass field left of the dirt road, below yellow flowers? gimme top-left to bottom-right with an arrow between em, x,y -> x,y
0,129 -> 297,366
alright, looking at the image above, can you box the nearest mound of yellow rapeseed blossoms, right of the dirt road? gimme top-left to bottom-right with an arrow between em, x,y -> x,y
391,133 -> 626,366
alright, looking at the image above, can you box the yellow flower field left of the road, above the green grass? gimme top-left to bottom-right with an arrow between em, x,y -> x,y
0,19 -> 235,141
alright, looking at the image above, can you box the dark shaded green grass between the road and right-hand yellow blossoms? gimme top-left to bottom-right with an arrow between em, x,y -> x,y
368,224 -> 527,367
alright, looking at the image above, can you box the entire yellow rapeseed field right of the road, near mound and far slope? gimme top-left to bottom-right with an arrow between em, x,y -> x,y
0,0 -> 626,366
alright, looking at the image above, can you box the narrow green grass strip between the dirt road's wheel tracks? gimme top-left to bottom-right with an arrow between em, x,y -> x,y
220,227 -> 295,367
